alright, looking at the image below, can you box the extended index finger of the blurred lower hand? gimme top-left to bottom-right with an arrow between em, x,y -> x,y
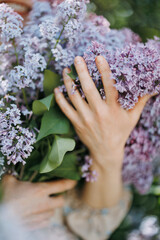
41,179 -> 77,195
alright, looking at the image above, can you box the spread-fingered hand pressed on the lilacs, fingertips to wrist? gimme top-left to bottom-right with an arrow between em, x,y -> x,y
55,56 -> 150,168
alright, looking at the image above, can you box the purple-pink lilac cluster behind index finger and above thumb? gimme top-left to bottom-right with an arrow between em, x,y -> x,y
84,42 -> 160,110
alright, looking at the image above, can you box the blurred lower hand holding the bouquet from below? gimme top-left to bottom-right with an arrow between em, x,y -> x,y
2,175 -> 76,230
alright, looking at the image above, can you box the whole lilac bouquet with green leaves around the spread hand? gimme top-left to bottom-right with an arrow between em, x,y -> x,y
0,0 -> 160,193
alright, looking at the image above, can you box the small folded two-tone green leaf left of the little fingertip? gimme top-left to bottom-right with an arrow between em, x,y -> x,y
32,93 -> 55,115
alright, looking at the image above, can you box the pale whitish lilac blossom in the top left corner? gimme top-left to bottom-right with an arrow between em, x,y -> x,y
0,3 -> 23,43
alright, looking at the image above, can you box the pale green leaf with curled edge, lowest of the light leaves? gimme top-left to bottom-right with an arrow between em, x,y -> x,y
40,136 -> 75,173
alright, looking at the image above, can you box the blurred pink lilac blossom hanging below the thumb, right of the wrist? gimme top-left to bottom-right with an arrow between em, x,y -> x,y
123,95 -> 160,194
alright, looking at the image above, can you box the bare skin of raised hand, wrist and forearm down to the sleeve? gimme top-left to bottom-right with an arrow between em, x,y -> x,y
55,56 -> 150,208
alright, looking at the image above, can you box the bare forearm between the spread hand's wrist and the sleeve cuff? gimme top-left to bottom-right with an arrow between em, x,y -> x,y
82,154 -> 124,208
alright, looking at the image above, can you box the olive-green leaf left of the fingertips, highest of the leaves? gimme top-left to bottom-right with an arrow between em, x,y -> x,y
43,69 -> 61,95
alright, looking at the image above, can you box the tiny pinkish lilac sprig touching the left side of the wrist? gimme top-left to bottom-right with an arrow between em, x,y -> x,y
81,155 -> 98,182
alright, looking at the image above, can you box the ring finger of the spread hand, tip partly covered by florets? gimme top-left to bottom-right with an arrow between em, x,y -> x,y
63,68 -> 89,116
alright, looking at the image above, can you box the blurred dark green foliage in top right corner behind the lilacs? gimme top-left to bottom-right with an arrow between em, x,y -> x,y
91,0 -> 160,41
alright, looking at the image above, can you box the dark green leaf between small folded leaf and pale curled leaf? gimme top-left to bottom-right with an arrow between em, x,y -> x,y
37,107 -> 70,141
